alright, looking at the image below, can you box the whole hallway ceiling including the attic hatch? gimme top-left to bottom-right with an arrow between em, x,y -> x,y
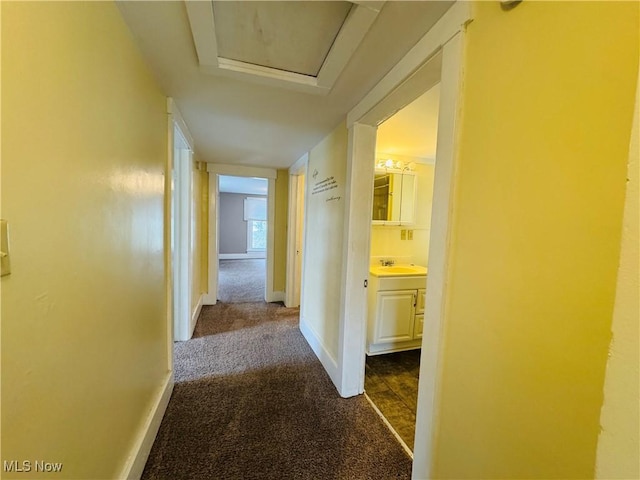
118,1 -> 453,168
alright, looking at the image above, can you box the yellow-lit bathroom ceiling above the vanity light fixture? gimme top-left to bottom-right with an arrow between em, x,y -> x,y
376,84 -> 440,161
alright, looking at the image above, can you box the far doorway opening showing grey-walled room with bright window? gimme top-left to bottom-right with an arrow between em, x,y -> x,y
217,175 -> 268,303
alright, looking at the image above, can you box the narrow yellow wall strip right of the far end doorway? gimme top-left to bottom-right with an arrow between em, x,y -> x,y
273,170 -> 289,292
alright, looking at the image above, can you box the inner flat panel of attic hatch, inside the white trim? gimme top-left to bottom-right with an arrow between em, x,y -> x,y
213,2 -> 353,77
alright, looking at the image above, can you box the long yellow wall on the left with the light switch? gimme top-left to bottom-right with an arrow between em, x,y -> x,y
1,2 -> 168,479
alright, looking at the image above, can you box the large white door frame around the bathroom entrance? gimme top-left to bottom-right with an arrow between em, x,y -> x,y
338,2 -> 472,479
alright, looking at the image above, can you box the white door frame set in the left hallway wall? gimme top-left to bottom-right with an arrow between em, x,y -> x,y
167,98 -> 195,344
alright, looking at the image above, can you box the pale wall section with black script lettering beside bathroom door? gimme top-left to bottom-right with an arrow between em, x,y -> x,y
300,122 -> 347,361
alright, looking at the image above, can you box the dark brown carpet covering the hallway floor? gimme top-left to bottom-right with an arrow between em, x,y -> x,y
142,303 -> 411,480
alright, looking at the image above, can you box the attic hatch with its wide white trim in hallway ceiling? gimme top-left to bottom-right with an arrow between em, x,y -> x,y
185,0 -> 384,94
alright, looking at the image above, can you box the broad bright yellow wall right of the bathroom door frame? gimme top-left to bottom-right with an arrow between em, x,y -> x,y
433,1 -> 640,479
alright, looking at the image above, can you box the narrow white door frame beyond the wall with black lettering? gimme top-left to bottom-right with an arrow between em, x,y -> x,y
284,153 -> 309,307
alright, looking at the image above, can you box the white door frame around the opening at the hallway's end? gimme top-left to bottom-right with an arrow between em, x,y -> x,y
202,163 -> 276,305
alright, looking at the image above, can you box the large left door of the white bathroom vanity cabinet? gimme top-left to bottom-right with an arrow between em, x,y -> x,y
374,290 -> 416,343
